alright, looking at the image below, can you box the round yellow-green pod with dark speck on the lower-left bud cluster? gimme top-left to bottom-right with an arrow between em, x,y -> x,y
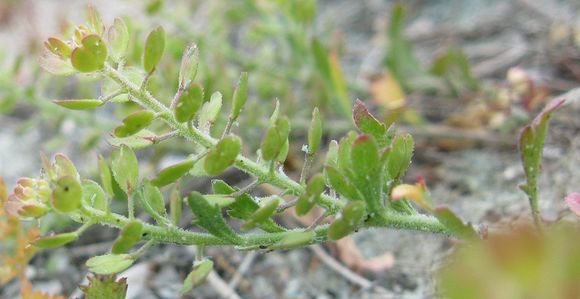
52,175 -> 83,213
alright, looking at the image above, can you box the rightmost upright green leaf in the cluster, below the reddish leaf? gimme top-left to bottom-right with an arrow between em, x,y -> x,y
386,134 -> 415,181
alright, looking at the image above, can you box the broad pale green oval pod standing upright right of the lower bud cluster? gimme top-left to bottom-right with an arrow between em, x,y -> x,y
111,145 -> 139,195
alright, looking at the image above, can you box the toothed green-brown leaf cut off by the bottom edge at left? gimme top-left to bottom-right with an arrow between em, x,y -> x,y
80,275 -> 127,299
